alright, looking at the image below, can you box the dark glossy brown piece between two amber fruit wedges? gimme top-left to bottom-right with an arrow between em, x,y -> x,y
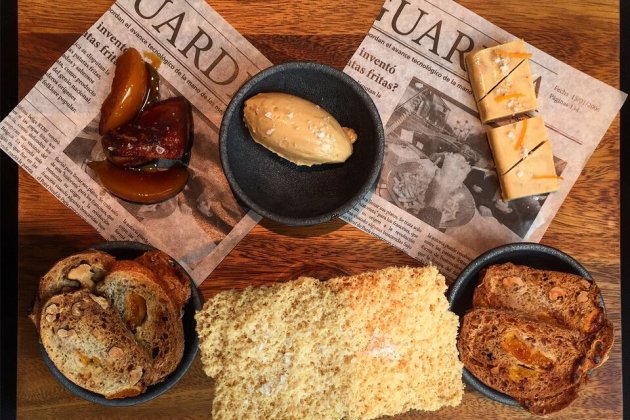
102,97 -> 192,167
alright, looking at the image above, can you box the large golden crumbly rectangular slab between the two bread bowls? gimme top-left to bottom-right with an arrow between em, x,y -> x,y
196,267 -> 463,419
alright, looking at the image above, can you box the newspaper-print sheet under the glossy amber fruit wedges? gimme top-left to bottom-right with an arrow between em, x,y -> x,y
0,0 -> 271,284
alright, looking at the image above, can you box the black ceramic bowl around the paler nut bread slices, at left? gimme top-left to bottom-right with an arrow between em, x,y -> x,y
39,241 -> 203,407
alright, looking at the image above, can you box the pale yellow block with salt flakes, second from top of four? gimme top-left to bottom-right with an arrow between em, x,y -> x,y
477,60 -> 538,124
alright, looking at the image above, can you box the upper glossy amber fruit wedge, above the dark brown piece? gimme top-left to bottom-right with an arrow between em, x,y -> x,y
99,48 -> 149,134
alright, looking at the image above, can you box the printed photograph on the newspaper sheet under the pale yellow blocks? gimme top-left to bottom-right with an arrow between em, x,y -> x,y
377,77 -> 565,246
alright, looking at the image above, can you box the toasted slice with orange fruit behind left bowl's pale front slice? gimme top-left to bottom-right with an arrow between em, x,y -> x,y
96,261 -> 184,385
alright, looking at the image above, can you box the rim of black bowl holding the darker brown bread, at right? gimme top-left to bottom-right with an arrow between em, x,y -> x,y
448,242 -> 605,407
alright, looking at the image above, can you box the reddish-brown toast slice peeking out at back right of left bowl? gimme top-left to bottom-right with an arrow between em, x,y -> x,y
135,250 -> 190,308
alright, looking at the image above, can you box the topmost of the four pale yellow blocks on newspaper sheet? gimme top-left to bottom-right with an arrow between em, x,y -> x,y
466,39 -> 530,101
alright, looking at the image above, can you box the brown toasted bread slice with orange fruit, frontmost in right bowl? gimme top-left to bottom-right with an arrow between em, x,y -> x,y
458,308 -> 586,412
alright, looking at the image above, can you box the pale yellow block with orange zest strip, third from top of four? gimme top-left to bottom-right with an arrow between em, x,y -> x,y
488,117 -> 549,175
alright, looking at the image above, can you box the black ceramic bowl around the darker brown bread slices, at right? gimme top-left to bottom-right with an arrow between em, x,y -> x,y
448,243 -> 604,406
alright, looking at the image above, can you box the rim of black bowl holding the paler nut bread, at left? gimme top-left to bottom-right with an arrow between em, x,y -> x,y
38,241 -> 203,407
